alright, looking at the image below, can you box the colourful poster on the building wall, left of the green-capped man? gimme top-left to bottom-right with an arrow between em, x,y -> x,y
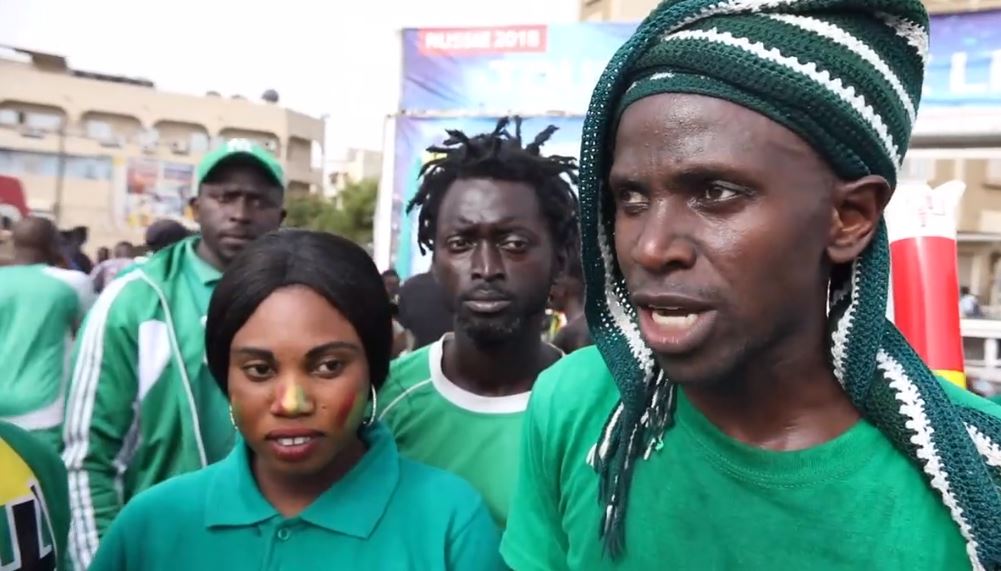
123,158 -> 194,228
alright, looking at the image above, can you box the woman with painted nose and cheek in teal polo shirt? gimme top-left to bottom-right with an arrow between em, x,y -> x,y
90,229 -> 503,571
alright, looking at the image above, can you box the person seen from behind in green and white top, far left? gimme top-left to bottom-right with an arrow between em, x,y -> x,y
0,217 -> 94,452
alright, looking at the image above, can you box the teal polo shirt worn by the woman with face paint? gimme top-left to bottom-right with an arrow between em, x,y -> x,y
90,423 -> 505,571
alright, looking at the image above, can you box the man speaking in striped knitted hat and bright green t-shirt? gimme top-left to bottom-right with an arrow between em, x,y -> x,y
502,0 -> 1001,571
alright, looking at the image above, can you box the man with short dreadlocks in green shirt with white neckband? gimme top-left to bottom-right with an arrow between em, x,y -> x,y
378,117 -> 578,525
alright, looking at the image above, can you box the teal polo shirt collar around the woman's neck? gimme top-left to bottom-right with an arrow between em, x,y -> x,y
205,423 -> 399,539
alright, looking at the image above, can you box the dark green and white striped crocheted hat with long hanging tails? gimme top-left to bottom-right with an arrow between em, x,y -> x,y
580,0 -> 1001,569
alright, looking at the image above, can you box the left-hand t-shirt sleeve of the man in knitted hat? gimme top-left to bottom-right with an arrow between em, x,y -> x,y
501,368 -> 568,571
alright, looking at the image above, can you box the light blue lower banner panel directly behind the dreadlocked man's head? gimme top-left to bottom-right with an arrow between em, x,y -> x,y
390,116 -> 584,278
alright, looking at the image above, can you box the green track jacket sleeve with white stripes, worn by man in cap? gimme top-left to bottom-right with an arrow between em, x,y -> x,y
63,289 -> 138,569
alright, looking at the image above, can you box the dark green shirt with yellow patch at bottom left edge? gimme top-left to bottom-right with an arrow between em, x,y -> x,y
0,422 -> 69,571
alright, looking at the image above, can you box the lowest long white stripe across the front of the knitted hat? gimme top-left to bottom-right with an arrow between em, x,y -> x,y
662,28 -> 903,166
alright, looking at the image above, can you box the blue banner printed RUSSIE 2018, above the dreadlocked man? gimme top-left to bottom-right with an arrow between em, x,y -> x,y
400,23 -> 636,115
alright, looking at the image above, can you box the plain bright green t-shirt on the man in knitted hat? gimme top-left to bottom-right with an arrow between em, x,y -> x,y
501,348 -> 1001,571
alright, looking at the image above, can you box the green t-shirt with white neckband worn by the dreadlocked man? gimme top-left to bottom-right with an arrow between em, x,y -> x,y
378,334 -> 531,527
